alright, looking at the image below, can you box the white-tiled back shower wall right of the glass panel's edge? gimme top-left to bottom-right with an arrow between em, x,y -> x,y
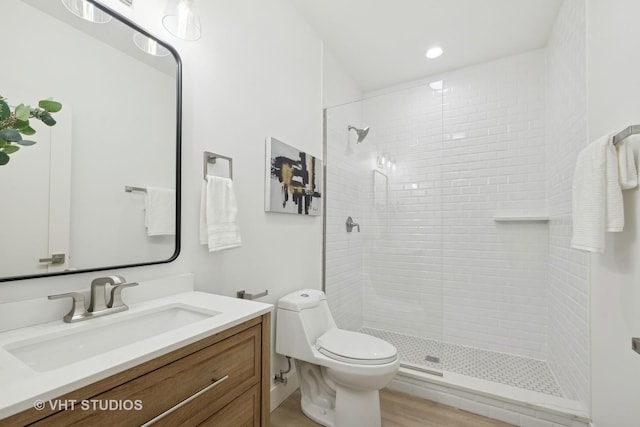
442,50 -> 548,359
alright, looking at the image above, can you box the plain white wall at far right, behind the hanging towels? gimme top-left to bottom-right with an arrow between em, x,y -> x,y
587,0 -> 640,427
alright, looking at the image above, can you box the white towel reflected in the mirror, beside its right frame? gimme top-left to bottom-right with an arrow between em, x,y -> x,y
144,187 -> 176,236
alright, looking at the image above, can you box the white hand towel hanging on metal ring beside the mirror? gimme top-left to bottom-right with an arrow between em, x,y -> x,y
200,175 -> 242,252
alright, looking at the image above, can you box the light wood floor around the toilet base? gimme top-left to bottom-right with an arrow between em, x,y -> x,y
271,390 -> 511,427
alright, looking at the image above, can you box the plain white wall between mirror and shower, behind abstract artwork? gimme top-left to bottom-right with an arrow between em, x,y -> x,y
176,0 -> 322,308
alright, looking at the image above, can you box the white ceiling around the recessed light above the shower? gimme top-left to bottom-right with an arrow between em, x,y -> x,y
291,0 -> 563,92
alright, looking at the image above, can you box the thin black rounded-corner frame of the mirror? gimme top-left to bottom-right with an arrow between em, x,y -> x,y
0,0 -> 182,283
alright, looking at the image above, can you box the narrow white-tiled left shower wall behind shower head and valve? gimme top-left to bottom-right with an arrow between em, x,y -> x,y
323,102 -> 370,331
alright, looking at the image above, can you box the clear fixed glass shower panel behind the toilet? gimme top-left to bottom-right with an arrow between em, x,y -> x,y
325,85 -> 443,367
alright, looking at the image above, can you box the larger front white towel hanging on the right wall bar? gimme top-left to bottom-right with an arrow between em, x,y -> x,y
571,134 -> 624,252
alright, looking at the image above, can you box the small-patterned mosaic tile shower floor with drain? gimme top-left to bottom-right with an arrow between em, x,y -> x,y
362,328 -> 564,397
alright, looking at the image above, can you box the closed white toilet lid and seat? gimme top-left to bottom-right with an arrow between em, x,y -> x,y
316,329 -> 398,365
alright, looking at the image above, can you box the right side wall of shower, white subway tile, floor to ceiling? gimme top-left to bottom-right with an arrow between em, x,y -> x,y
547,0 -> 590,406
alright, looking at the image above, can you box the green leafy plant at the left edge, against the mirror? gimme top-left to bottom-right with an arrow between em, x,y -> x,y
0,95 -> 62,166
